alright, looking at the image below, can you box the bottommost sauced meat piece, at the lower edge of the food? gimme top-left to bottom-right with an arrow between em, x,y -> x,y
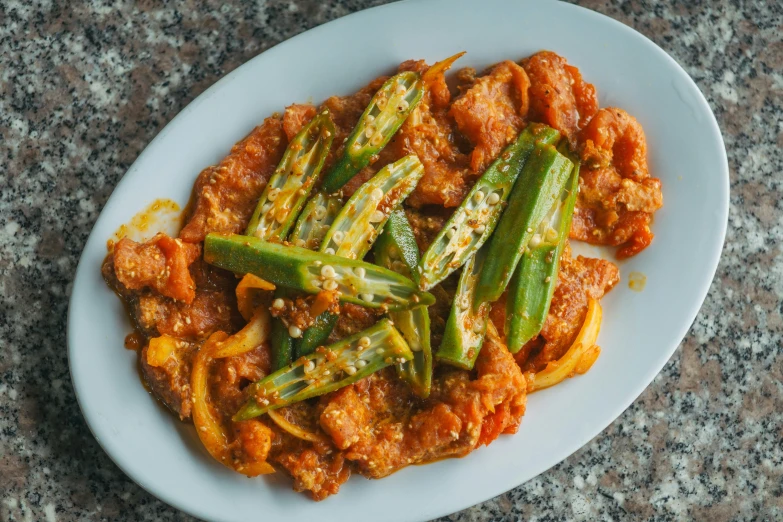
272,445 -> 351,500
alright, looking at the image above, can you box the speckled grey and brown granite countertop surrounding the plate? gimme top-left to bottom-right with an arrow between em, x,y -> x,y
0,0 -> 783,522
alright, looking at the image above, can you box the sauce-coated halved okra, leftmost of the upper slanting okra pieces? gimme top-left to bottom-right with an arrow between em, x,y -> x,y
245,109 -> 335,242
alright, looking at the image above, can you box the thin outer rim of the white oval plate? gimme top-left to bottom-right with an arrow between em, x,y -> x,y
66,0 -> 730,517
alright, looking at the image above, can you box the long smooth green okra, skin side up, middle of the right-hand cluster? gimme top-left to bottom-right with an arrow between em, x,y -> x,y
474,144 -> 574,306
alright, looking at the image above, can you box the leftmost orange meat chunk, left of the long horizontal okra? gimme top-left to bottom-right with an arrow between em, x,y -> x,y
113,233 -> 201,303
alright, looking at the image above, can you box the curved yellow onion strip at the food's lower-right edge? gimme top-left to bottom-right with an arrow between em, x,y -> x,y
528,299 -> 601,392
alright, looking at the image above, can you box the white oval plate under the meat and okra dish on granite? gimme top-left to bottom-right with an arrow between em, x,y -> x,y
68,0 -> 729,522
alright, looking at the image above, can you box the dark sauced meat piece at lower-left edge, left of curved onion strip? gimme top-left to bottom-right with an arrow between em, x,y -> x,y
139,341 -> 198,420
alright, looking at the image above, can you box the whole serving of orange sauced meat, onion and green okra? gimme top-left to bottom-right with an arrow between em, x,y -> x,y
102,51 -> 663,500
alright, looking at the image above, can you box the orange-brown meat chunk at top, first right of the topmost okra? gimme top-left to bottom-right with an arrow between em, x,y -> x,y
450,61 -> 530,173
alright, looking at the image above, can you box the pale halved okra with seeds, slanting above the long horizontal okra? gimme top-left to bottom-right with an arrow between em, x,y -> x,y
321,154 -> 424,259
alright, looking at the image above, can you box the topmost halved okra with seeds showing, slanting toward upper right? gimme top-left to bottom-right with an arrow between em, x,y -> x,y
323,71 -> 424,193
